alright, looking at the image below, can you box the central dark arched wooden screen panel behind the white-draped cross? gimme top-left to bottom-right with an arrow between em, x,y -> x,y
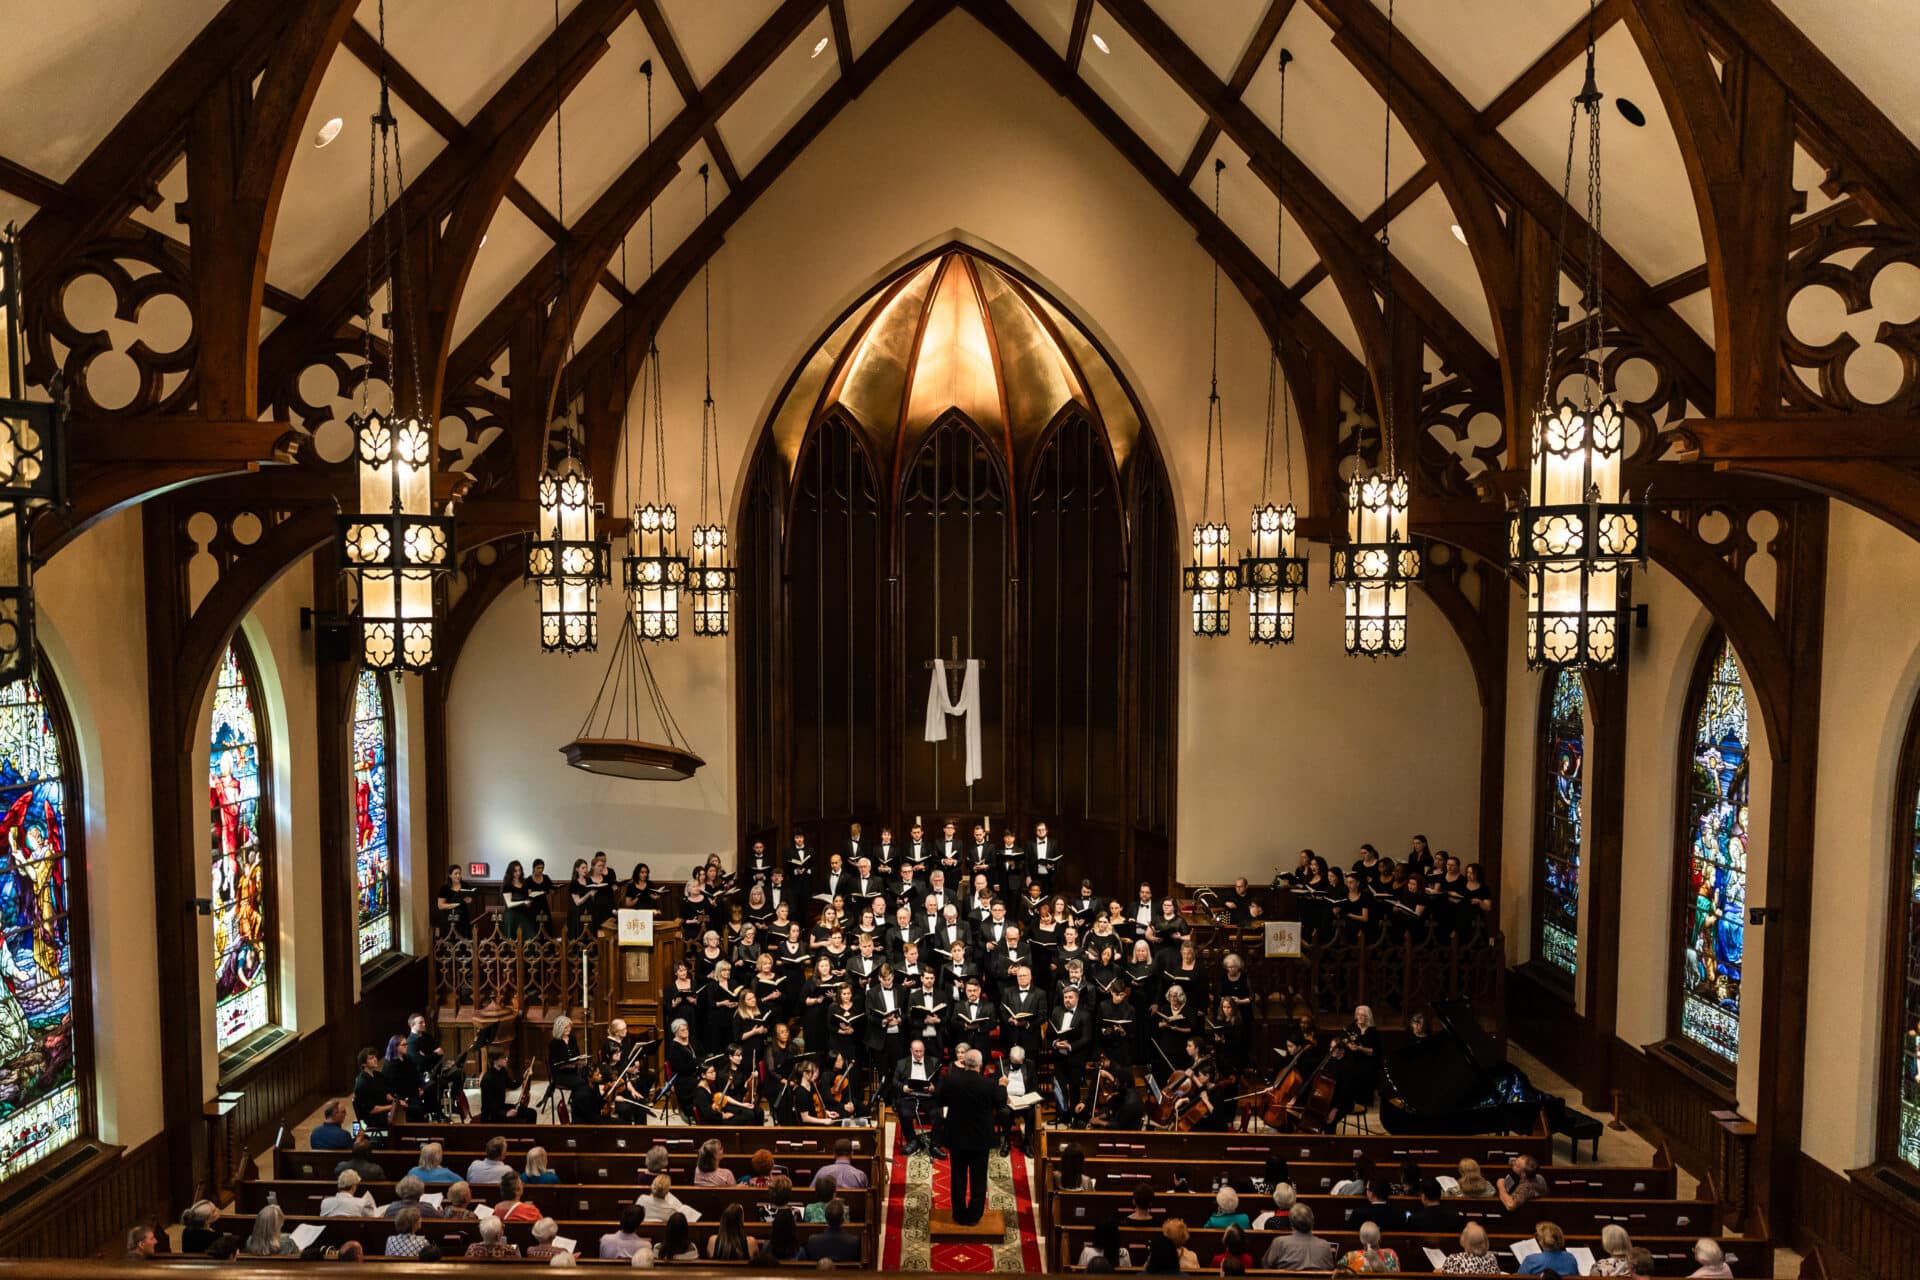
898,413 -> 1012,809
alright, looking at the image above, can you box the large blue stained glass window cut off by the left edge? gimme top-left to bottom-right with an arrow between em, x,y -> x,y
0,679 -> 83,1180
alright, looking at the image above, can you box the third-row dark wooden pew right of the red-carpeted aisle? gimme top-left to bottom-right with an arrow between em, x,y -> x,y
1050,1192 -> 1720,1240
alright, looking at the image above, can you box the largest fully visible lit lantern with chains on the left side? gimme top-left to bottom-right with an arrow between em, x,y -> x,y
338,0 -> 453,672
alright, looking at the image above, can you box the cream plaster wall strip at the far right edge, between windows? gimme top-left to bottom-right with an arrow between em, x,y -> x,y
1801,503 -> 1920,1171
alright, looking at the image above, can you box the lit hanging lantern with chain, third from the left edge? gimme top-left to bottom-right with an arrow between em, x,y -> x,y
526,4 -> 612,654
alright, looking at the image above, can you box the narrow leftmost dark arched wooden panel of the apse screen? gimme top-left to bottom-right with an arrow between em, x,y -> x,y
735,441 -> 787,835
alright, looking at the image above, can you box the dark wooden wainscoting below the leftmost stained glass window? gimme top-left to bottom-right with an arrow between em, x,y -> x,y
0,1134 -> 167,1259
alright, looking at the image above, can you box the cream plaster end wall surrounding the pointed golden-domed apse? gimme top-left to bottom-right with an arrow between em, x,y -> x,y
449,13 -> 1478,879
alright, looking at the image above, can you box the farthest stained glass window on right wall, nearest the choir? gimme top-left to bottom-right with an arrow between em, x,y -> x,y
1534,670 -> 1586,979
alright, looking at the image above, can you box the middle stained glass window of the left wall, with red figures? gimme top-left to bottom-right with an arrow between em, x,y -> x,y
207,641 -> 273,1050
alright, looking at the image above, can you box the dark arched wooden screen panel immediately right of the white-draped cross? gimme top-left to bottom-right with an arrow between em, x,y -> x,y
1020,411 -> 1127,825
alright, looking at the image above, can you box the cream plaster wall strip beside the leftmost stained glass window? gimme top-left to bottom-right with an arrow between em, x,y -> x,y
35,510 -> 165,1146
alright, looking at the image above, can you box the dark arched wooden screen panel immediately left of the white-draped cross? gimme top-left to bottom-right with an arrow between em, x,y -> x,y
785,418 -> 887,821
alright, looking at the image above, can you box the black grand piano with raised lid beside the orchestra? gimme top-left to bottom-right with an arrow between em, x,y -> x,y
1380,1000 -> 1565,1134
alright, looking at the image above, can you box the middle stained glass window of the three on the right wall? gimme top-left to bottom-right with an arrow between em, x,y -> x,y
1680,639 -> 1747,1061
